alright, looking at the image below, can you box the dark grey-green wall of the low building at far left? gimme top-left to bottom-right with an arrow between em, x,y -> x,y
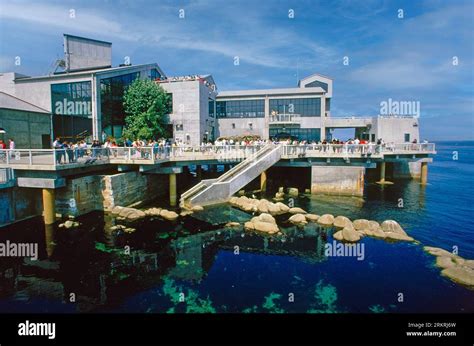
0,108 -> 51,149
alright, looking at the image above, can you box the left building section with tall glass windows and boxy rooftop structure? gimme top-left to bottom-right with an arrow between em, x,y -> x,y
0,35 -> 164,140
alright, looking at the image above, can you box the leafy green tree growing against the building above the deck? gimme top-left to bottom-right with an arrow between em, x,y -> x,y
123,79 -> 170,140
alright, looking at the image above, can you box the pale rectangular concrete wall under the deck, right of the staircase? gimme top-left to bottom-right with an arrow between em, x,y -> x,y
311,166 -> 365,196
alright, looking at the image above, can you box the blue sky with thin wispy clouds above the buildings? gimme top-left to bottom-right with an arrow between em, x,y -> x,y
0,0 -> 474,140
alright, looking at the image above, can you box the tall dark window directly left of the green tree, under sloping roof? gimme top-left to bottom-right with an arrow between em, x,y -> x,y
100,72 -> 140,137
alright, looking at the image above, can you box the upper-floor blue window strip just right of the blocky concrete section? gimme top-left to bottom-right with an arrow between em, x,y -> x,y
216,100 -> 265,118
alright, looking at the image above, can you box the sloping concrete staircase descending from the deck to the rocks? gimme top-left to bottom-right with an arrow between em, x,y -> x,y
180,144 -> 281,208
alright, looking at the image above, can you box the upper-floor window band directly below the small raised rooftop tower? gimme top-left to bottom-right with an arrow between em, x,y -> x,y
270,98 -> 321,117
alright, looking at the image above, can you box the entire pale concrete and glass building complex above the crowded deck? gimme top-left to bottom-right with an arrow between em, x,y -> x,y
0,34 -> 420,145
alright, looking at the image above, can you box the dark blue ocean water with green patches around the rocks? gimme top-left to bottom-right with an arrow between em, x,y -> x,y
0,142 -> 474,313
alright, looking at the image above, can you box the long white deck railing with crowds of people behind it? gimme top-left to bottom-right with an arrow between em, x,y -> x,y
0,143 -> 435,167
